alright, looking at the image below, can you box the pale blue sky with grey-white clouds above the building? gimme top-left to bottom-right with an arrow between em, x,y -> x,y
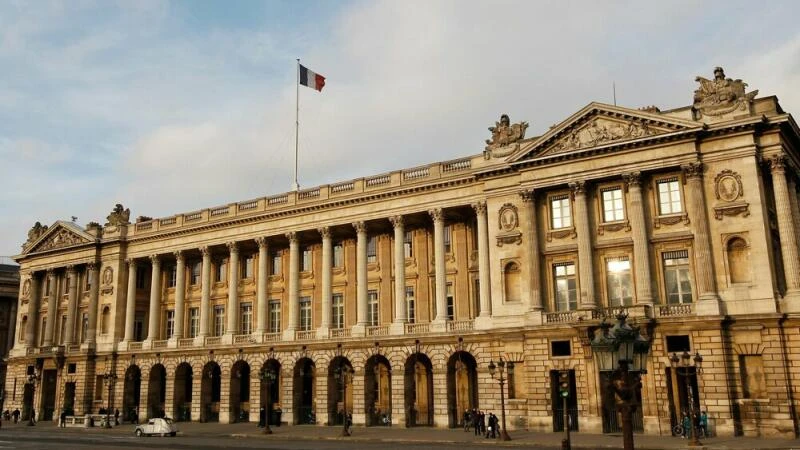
0,0 -> 800,255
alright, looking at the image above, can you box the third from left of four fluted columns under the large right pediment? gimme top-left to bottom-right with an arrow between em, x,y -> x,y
622,172 -> 653,306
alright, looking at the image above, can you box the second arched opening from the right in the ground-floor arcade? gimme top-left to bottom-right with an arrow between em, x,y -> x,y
404,353 -> 433,427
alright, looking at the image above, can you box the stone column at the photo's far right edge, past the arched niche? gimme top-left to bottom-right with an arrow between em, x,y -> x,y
769,155 -> 800,313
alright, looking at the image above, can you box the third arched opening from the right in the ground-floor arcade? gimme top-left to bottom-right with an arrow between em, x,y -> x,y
364,355 -> 392,426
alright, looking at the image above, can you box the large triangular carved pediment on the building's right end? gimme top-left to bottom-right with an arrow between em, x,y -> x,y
508,103 -> 703,163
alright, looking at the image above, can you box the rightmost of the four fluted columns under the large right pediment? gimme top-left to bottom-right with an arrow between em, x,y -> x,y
681,161 -> 720,315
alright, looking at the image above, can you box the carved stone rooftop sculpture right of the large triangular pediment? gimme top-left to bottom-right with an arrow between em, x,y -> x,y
694,67 -> 758,116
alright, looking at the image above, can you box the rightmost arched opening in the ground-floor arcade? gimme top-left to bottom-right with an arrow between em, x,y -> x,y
447,351 -> 478,427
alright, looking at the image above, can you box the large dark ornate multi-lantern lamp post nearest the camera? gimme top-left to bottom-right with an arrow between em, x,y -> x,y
591,312 -> 650,450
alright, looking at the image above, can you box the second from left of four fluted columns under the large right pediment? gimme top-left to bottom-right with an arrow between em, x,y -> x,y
569,181 -> 597,309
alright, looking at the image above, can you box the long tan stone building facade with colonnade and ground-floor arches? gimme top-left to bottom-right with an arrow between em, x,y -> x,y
6,68 -> 800,436
